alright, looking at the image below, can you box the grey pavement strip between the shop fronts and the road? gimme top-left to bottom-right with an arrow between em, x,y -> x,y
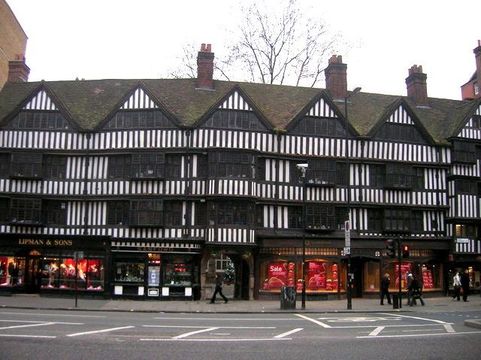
0,294 -> 481,329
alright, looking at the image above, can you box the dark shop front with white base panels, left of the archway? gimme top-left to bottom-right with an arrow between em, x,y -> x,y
111,241 -> 201,300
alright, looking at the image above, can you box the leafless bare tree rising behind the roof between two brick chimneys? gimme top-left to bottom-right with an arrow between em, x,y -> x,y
171,0 -> 340,87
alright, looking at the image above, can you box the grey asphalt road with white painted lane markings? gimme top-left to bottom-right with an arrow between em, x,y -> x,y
0,309 -> 481,360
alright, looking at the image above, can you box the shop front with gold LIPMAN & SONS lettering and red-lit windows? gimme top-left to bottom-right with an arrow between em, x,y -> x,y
0,235 -> 109,295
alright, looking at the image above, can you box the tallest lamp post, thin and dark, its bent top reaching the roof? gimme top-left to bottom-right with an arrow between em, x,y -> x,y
344,87 -> 361,310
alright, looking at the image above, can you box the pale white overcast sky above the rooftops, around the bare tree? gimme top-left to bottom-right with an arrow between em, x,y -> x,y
7,0 -> 481,99
